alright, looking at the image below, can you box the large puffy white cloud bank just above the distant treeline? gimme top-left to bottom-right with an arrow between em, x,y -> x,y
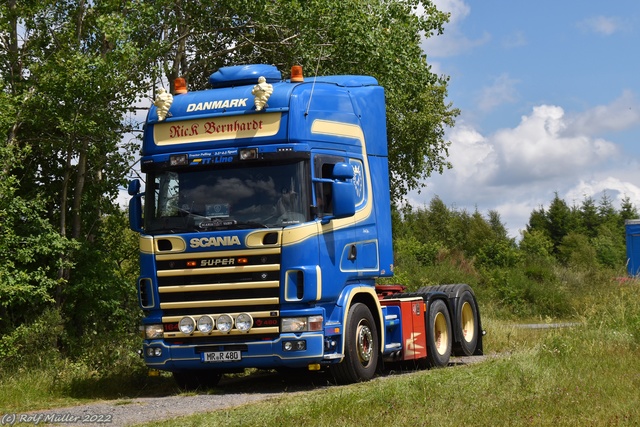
409,93 -> 640,237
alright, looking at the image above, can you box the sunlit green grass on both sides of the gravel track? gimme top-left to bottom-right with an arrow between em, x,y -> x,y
0,280 -> 640,427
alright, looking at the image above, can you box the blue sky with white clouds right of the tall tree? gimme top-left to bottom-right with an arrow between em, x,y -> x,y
416,0 -> 640,237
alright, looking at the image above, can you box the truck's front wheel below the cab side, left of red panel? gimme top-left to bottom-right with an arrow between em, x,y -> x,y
331,303 -> 380,384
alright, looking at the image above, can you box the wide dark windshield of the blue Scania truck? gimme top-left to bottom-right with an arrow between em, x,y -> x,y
145,161 -> 310,233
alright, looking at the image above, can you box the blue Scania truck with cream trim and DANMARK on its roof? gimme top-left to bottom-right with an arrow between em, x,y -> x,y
129,65 -> 483,388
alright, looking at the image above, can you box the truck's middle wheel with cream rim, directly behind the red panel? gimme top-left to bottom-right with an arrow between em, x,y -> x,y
427,299 -> 453,368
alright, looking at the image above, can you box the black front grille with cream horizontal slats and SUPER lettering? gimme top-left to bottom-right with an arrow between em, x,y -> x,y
156,248 -> 280,343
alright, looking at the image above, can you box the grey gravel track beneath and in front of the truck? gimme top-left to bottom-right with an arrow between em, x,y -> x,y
17,356 -> 487,427
